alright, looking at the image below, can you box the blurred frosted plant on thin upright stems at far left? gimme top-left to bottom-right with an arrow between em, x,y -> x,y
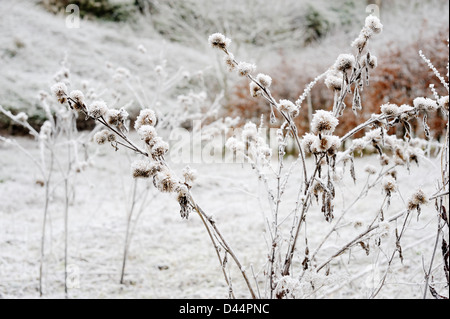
0,64 -> 96,296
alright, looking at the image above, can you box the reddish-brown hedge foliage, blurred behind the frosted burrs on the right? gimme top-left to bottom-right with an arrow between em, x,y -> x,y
225,29 -> 449,140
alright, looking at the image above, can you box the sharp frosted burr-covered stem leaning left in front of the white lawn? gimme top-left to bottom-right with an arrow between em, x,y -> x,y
51,85 -> 256,298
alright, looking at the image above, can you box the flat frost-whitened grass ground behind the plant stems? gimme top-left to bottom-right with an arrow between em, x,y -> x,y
0,138 -> 442,298
